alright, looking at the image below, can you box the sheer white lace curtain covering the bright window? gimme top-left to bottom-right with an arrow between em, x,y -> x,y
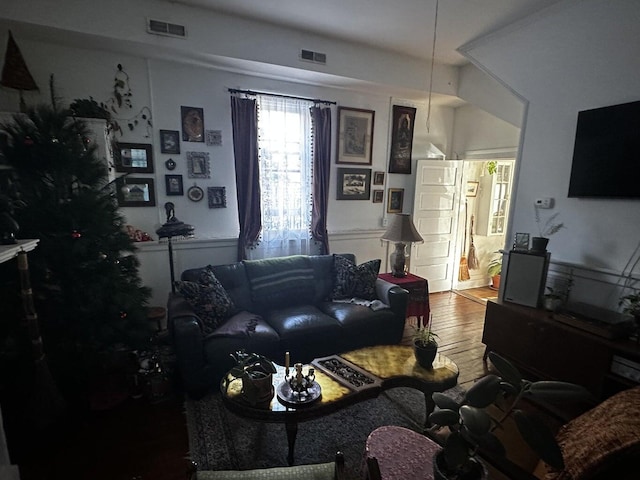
248,95 -> 314,259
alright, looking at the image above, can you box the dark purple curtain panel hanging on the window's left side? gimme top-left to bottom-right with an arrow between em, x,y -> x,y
231,95 -> 262,261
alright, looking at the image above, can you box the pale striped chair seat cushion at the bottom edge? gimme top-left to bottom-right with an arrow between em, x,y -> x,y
196,462 -> 335,480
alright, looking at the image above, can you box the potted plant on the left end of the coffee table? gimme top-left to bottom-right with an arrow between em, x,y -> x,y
227,350 -> 276,405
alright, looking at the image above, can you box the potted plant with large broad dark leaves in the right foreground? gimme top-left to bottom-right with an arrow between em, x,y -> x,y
429,352 -> 594,480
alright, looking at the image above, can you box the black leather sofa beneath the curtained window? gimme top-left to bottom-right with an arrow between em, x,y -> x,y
167,254 -> 408,398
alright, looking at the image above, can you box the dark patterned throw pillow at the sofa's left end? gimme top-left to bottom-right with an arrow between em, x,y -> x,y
175,272 -> 236,335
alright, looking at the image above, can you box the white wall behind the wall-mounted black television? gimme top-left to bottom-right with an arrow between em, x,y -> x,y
465,0 -> 640,308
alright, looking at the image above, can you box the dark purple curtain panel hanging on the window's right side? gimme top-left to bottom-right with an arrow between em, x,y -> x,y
310,106 -> 331,254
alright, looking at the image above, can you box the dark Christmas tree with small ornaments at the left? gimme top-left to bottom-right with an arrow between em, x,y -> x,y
0,103 -> 152,394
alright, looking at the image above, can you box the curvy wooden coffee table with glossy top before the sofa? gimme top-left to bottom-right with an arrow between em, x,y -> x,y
220,345 -> 458,465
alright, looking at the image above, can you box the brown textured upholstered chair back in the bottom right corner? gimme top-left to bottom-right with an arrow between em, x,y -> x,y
545,386 -> 640,480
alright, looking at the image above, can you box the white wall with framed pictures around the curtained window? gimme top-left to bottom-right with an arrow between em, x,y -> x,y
0,0 -> 513,304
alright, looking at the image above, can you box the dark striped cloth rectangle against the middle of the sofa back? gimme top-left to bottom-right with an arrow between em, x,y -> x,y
243,255 -> 315,312
